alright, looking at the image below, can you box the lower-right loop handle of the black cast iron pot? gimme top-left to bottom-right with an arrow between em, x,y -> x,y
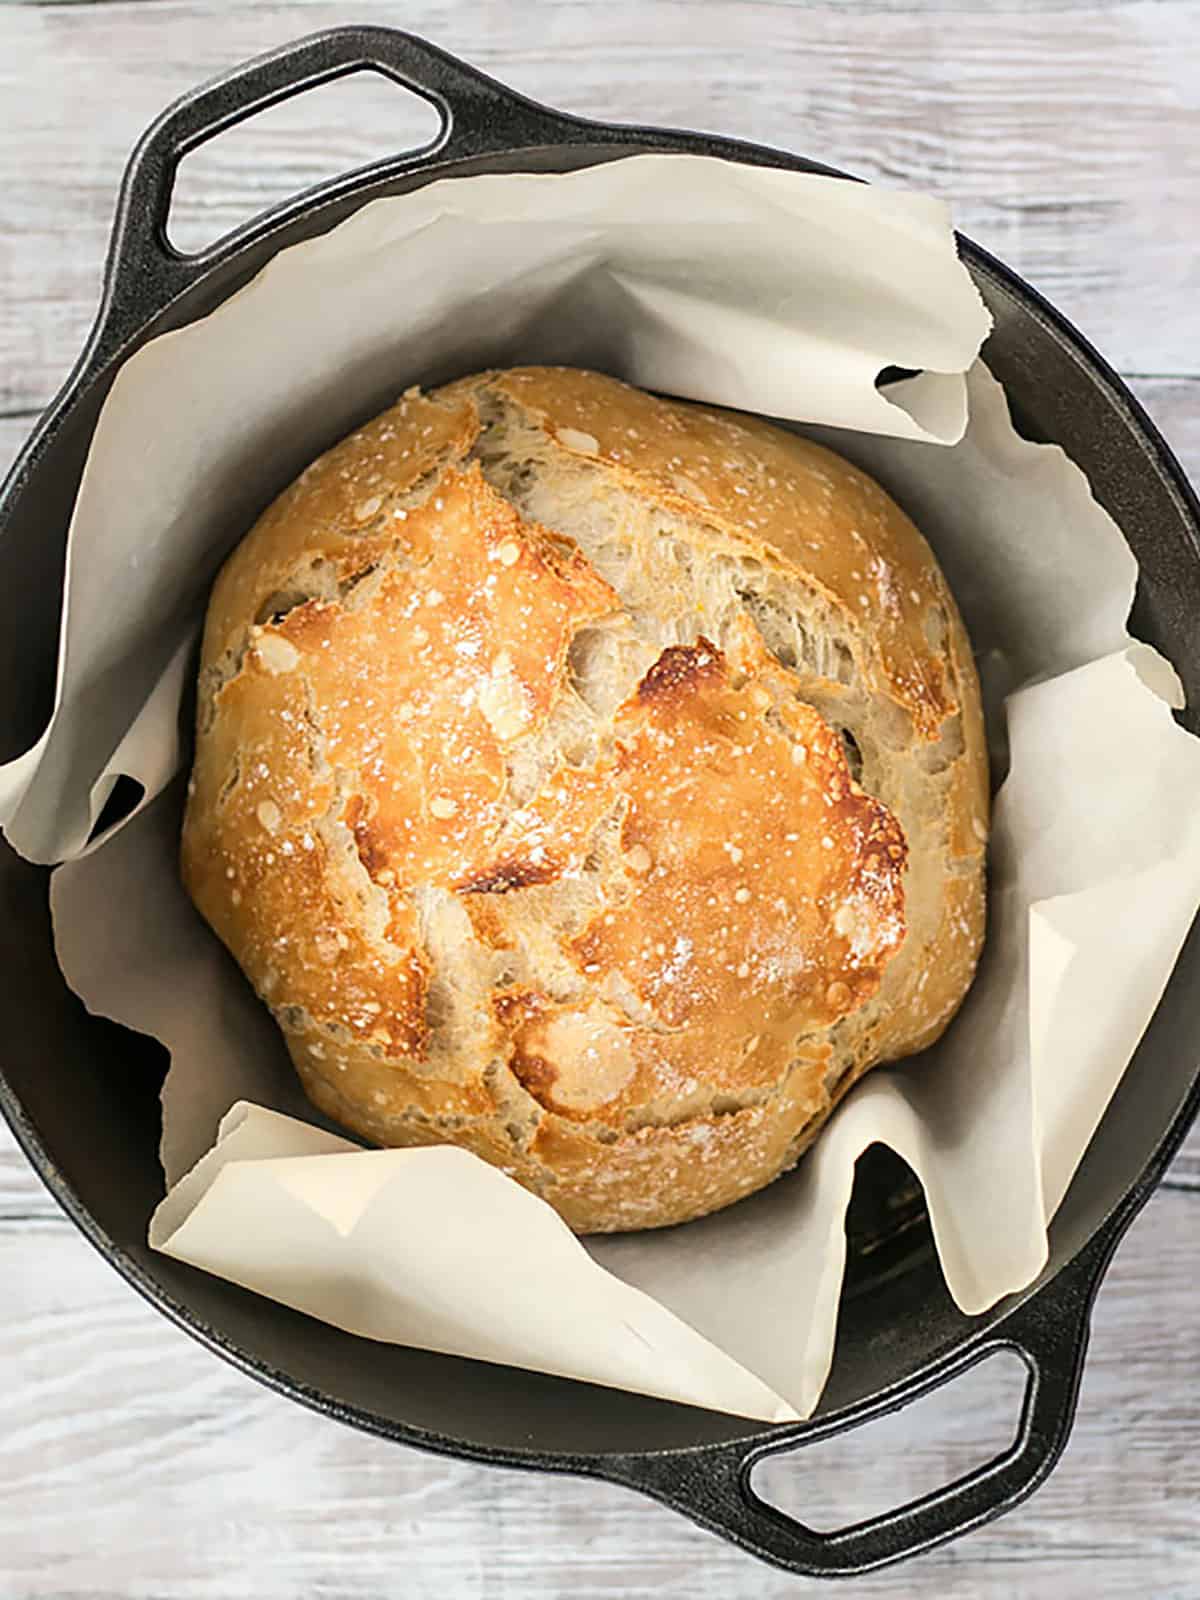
600,1246 -> 1110,1578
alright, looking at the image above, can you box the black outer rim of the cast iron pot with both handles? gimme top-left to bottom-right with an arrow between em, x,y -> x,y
0,26 -> 1200,1576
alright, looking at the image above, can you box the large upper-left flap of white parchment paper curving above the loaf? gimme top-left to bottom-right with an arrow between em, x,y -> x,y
0,155 -> 989,861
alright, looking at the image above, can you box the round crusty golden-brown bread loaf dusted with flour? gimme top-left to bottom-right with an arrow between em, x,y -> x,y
182,368 -> 987,1232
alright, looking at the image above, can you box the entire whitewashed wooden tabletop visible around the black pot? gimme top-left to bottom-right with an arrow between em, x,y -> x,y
0,0 -> 1200,1600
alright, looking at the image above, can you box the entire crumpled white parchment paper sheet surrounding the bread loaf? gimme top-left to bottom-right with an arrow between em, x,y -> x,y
0,157 -> 1200,1419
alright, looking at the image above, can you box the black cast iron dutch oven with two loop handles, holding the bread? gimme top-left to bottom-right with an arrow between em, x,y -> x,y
0,27 -> 1200,1574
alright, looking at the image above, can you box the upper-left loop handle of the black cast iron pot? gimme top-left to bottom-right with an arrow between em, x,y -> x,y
90,26 -> 582,365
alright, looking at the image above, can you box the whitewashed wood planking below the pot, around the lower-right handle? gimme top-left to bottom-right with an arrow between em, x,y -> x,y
0,1113 -> 1200,1600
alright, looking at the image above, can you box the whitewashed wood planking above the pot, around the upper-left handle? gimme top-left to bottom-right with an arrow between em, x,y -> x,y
0,0 -> 1200,413
